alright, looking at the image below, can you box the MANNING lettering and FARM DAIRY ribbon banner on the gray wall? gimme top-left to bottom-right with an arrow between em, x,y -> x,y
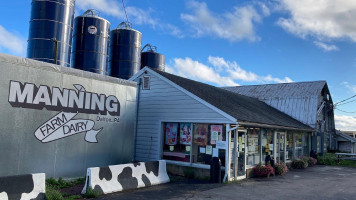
8,81 -> 120,143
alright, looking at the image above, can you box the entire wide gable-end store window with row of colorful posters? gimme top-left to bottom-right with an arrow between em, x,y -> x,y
162,122 -> 226,166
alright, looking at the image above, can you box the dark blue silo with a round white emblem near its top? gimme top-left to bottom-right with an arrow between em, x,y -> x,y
70,10 -> 110,75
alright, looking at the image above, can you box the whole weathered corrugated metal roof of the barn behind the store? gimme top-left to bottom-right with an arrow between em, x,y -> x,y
224,81 -> 326,128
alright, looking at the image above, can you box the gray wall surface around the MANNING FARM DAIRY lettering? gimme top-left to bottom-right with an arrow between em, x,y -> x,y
0,54 -> 137,178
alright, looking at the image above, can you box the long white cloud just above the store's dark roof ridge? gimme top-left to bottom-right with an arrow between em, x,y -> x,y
166,56 -> 292,86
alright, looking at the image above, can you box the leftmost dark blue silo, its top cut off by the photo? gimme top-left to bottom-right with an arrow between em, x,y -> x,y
27,0 -> 75,67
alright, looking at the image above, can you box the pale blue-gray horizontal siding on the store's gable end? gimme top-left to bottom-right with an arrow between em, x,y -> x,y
135,73 -> 234,161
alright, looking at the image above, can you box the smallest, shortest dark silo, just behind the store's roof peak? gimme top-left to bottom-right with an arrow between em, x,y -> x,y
141,44 -> 166,71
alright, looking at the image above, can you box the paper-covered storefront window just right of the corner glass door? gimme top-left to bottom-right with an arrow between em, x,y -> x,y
247,129 -> 261,166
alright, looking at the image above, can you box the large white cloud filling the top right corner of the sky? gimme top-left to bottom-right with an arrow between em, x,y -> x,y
277,0 -> 356,42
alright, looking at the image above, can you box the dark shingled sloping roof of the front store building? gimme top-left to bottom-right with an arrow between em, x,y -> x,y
147,68 -> 313,131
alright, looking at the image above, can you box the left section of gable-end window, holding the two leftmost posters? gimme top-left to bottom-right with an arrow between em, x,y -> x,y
163,123 -> 192,162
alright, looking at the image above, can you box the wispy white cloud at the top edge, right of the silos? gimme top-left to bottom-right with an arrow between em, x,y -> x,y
181,1 -> 270,42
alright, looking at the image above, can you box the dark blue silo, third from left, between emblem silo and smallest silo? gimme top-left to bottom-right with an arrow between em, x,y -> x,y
108,22 -> 142,79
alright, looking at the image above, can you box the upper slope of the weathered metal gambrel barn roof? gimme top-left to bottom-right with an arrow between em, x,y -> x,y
223,81 -> 326,99
